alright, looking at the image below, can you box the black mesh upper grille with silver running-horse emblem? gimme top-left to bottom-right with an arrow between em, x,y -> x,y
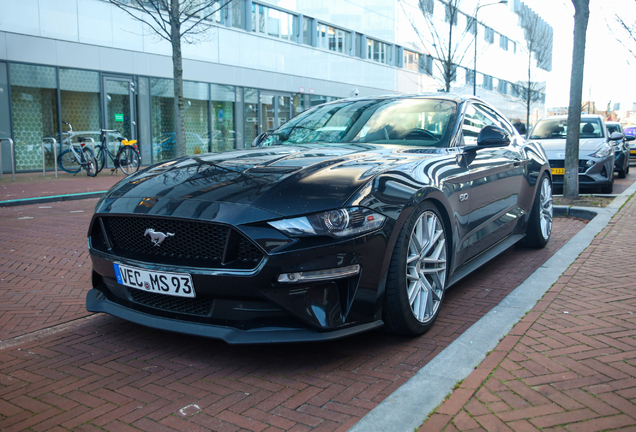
91,216 -> 263,269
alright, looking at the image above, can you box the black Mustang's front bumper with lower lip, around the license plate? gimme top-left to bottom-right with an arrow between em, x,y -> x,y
86,219 -> 395,344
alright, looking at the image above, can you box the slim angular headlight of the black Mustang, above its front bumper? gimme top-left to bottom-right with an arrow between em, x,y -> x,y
268,207 -> 386,237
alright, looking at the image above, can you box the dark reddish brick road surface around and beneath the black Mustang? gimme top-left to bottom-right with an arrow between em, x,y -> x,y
0,199 -> 585,432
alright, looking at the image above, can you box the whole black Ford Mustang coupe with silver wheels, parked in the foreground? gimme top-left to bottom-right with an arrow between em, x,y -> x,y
86,94 -> 552,343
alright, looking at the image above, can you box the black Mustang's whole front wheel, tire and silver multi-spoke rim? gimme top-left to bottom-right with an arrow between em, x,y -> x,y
382,201 -> 449,336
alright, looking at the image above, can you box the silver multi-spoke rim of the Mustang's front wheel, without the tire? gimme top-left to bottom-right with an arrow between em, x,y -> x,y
406,211 -> 446,324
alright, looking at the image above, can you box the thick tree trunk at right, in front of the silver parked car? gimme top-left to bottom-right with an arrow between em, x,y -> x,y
563,0 -> 590,200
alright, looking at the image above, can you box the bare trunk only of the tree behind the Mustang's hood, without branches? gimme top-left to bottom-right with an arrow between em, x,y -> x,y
170,0 -> 186,157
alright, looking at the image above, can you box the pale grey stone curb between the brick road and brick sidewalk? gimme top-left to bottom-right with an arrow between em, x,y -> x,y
349,183 -> 636,432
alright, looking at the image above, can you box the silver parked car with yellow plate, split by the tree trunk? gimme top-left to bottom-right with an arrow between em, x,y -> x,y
530,114 -> 615,193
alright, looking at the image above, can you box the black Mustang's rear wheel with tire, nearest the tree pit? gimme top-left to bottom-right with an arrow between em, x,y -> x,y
524,173 -> 554,249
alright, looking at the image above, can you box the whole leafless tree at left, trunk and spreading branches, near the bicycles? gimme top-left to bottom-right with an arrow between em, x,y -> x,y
108,0 -> 231,157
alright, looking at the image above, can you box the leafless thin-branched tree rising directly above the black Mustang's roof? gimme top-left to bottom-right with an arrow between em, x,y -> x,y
400,0 -> 474,92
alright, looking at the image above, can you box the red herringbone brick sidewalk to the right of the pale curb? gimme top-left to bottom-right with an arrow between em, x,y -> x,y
420,196 -> 636,432
